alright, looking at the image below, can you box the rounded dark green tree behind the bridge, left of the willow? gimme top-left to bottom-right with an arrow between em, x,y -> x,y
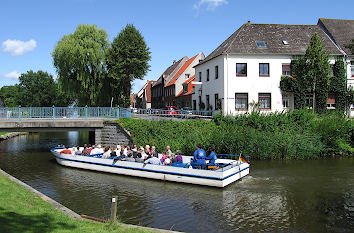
18,70 -> 57,107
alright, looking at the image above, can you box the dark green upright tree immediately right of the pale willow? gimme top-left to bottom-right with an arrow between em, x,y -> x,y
105,24 -> 151,107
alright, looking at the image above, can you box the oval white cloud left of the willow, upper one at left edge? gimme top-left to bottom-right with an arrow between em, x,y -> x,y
2,39 -> 37,56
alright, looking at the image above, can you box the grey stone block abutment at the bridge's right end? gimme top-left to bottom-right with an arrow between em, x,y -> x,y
95,121 -> 133,146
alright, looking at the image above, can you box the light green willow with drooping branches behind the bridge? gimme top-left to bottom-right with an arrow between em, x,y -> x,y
52,25 -> 109,106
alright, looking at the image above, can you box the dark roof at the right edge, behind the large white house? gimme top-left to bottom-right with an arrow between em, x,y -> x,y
318,18 -> 354,56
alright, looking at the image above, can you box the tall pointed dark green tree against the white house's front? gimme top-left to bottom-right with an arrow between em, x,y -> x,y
281,33 -> 331,113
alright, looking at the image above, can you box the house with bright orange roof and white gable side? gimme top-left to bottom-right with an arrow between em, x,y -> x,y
164,52 -> 205,108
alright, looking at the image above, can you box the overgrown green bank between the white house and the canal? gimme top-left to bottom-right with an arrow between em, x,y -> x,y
119,110 -> 354,159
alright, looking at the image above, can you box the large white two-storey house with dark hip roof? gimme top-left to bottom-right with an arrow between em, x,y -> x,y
192,22 -> 343,115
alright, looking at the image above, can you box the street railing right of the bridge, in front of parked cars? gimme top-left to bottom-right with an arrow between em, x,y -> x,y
131,108 -> 214,119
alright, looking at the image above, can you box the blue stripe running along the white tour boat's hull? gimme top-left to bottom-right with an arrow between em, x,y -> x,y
55,156 -> 249,180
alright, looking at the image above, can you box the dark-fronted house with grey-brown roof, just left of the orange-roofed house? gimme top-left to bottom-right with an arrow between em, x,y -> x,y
151,57 -> 188,108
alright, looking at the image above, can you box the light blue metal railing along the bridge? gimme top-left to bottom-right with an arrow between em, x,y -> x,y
0,106 -> 131,120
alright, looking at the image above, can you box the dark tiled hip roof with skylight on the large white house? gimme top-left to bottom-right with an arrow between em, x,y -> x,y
200,23 -> 343,64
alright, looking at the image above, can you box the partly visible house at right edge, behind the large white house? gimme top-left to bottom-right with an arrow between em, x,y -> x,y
317,18 -> 354,116
